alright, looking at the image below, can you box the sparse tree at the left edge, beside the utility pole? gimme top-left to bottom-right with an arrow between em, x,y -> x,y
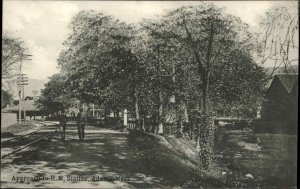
2,33 -> 28,88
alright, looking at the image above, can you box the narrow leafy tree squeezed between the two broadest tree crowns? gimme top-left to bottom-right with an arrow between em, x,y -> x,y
132,22 -> 175,134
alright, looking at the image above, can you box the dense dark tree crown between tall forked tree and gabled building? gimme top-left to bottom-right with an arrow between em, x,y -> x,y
210,49 -> 267,113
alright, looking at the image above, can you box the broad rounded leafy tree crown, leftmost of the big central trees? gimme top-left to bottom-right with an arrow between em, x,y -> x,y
58,11 -> 134,109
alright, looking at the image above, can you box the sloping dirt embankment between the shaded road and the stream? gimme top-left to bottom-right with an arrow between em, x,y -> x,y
129,132 -> 225,188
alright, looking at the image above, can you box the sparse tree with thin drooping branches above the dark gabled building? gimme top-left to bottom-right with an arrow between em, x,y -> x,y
259,7 -> 299,78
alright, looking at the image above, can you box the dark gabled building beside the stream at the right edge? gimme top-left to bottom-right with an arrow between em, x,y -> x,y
261,73 -> 298,133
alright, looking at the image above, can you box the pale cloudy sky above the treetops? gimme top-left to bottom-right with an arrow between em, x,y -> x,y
2,0 -> 297,79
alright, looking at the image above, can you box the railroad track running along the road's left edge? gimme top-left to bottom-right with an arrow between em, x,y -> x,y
1,123 -> 59,160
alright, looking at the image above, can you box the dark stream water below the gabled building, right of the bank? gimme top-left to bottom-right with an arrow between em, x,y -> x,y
215,129 -> 297,187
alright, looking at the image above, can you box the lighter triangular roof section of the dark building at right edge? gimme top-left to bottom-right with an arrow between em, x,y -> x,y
273,73 -> 298,93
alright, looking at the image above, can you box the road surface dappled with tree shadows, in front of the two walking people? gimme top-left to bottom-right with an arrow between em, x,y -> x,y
1,129 -> 171,188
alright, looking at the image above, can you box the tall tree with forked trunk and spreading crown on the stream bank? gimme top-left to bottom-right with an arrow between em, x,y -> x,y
143,3 -> 253,167
